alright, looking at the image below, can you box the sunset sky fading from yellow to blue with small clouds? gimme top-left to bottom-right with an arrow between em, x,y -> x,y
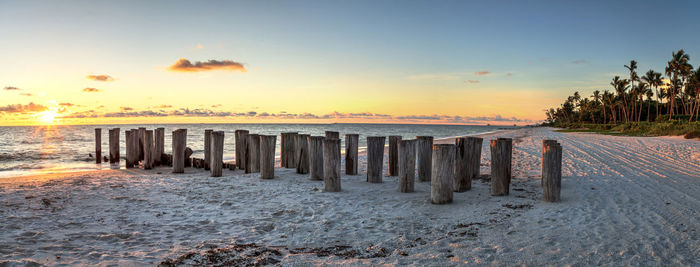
0,0 -> 700,125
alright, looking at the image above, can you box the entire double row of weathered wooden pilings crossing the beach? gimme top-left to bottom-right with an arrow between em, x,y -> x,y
95,128 -> 562,204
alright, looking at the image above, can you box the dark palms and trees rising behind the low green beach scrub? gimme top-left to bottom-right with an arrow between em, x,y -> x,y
546,50 -> 700,125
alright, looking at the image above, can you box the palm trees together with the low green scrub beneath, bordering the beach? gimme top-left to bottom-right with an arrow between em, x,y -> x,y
545,50 -> 700,138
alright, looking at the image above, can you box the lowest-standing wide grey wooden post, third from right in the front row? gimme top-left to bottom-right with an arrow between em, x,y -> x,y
430,144 -> 455,204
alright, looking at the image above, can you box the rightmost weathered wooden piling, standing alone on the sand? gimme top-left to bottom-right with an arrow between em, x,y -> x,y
542,140 -> 562,202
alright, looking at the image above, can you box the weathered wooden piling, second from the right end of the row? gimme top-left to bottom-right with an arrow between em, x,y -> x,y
489,138 -> 513,196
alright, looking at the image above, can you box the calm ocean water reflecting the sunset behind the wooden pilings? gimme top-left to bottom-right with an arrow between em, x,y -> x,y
0,123 -> 509,178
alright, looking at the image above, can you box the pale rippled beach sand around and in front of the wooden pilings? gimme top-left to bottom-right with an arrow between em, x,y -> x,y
0,128 -> 700,266
